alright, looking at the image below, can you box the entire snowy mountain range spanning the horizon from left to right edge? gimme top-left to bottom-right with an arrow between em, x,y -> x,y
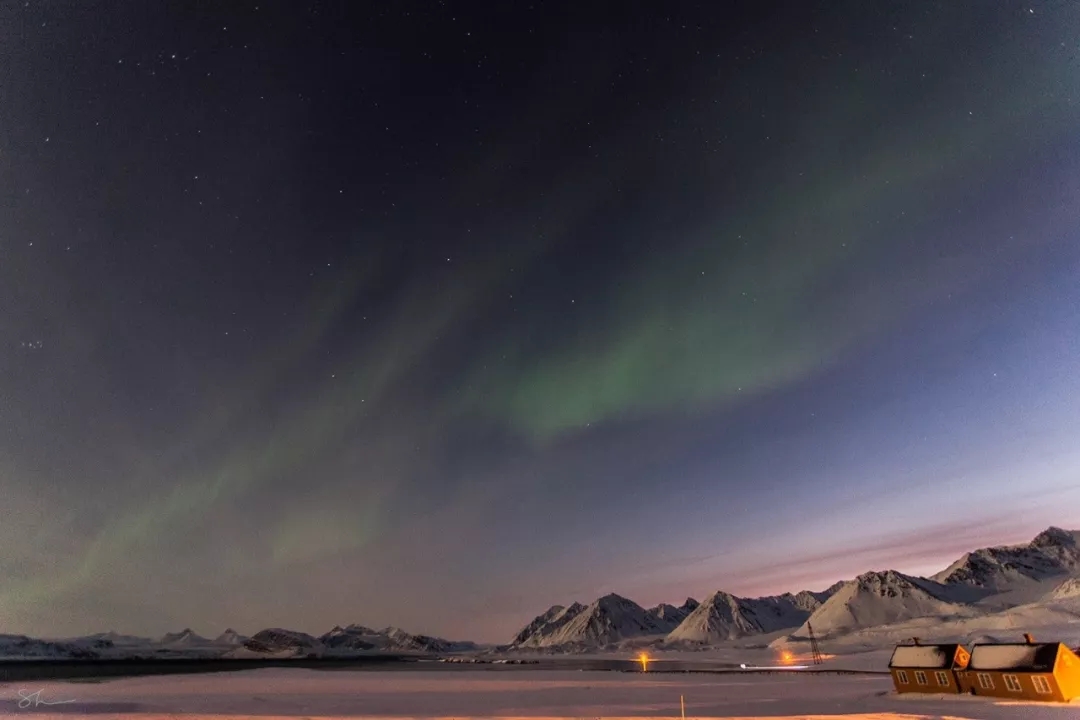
6,526 -> 1080,657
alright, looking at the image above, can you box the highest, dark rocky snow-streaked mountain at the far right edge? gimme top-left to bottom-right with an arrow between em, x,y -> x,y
931,527 -> 1080,594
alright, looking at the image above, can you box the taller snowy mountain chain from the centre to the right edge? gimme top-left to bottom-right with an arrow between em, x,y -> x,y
509,526 -> 1080,650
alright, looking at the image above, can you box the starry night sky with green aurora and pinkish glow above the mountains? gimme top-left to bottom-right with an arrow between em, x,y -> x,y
0,0 -> 1080,641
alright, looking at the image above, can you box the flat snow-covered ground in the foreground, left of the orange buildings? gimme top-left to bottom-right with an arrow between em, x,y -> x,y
0,668 -> 1080,720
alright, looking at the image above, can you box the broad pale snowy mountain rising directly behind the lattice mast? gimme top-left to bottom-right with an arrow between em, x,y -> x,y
795,570 -> 978,637
